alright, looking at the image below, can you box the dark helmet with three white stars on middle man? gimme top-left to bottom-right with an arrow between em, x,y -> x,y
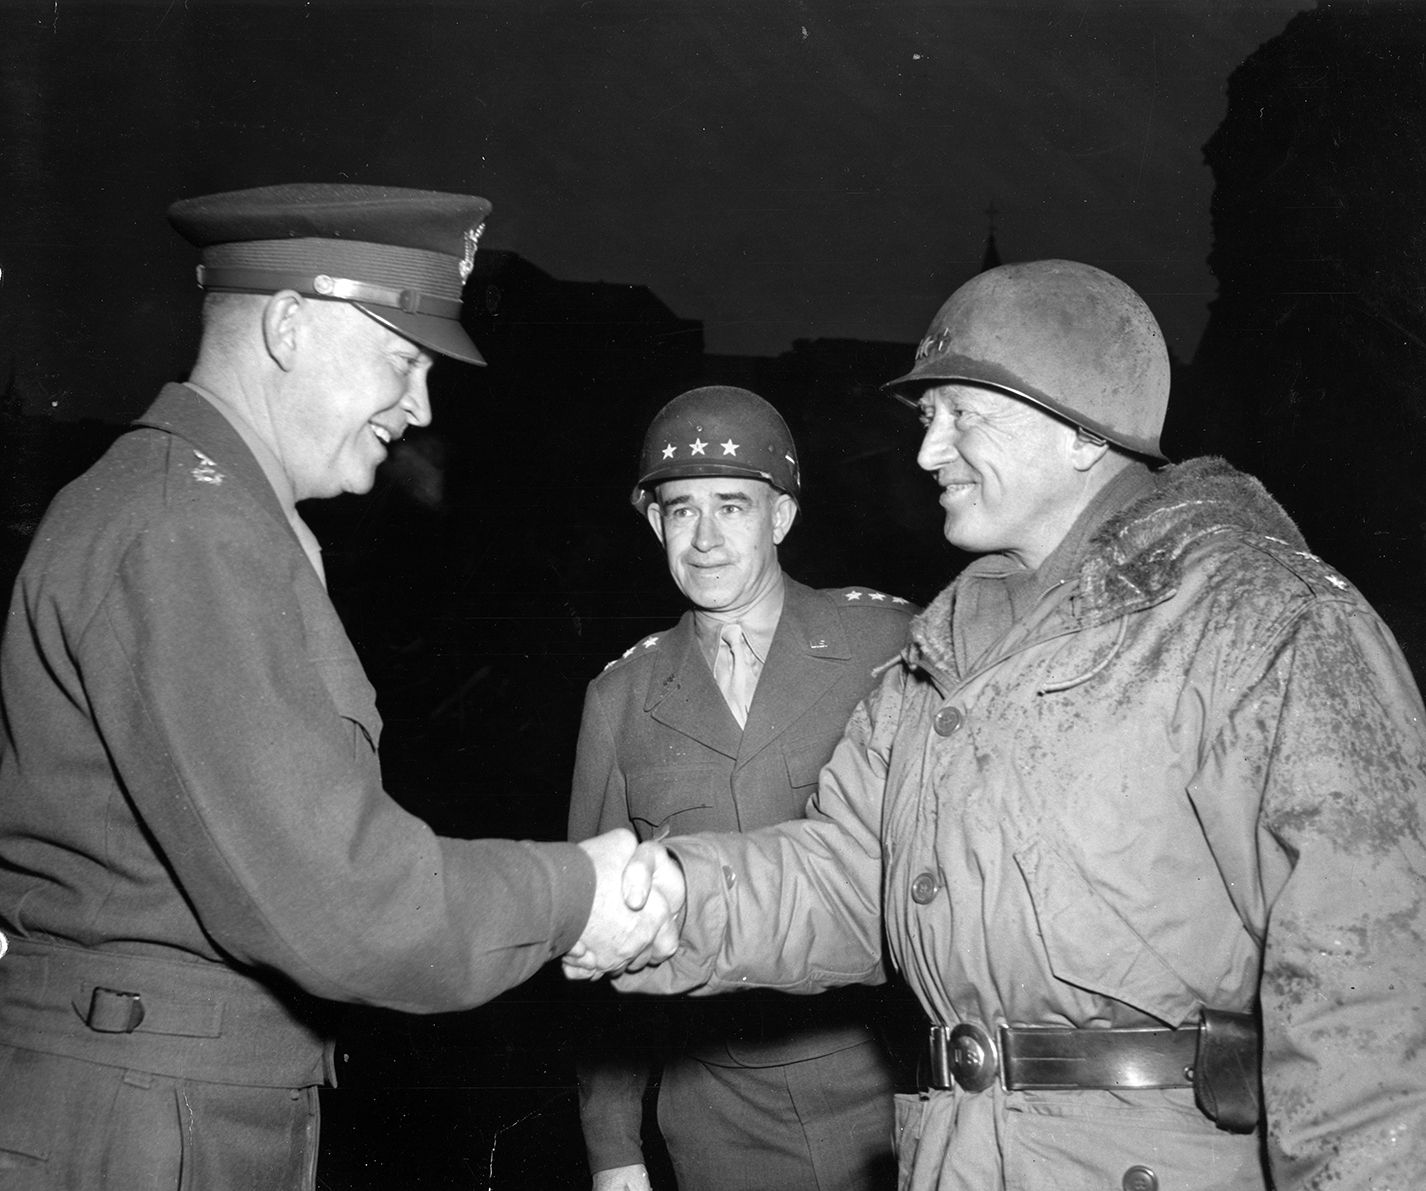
629,385 -> 801,513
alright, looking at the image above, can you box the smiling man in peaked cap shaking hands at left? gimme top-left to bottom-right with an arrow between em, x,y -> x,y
0,185 -> 666,1191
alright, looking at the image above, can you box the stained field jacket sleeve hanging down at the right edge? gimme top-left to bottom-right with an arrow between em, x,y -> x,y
1215,599 -> 1426,1191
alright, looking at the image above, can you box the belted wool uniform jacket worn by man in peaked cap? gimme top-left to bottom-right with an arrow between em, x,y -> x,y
0,385 -> 593,1095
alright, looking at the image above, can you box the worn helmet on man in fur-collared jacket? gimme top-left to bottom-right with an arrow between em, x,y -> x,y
886,261 -> 1169,459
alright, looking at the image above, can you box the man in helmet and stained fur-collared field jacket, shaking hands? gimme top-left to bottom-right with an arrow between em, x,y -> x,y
587,261 -> 1426,1191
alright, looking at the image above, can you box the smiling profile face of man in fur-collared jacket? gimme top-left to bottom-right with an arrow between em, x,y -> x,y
917,384 -> 1104,569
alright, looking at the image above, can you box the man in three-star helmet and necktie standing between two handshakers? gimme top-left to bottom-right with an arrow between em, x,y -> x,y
569,387 -> 914,1191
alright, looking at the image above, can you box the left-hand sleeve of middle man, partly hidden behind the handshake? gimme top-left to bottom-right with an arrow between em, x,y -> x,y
569,683 -> 655,1171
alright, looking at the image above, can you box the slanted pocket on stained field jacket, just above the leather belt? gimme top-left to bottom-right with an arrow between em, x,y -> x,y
1015,840 -> 1199,1026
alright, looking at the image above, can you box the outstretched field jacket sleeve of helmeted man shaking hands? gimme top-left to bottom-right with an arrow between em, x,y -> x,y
615,676 -> 887,993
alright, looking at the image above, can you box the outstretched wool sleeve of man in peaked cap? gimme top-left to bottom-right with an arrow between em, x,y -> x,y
76,502 -> 593,1011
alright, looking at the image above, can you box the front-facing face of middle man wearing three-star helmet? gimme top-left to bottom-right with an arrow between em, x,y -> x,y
646,475 -> 797,618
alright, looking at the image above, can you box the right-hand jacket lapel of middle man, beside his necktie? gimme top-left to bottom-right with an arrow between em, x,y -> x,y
735,578 -> 851,765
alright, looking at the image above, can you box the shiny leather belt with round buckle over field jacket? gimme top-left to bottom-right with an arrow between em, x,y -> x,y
930,1023 -> 1199,1091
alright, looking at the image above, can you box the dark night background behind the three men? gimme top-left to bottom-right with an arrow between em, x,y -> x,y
0,0 -> 1426,1188
